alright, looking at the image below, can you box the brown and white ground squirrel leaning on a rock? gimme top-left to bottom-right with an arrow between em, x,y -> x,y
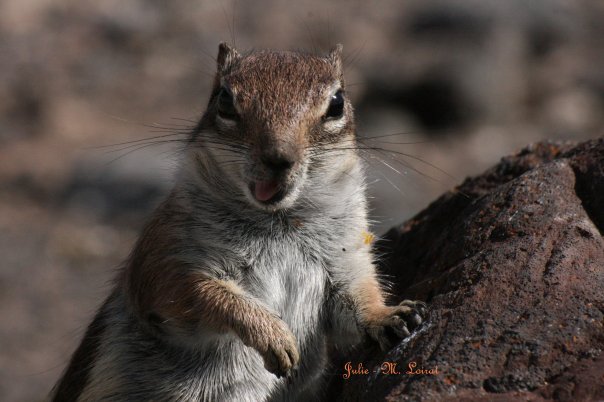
52,44 -> 424,402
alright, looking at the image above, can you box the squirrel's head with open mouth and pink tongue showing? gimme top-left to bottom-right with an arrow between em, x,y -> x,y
191,43 -> 356,211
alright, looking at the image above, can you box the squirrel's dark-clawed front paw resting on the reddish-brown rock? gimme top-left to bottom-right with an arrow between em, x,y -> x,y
365,300 -> 428,351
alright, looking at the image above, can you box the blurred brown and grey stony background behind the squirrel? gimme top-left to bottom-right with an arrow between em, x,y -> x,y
0,0 -> 604,401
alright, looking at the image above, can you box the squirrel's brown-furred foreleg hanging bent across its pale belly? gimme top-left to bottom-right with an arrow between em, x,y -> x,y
125,197 -> 299,372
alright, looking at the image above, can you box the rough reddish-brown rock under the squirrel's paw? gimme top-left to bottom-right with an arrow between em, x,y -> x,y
330,139 -> 604,401
